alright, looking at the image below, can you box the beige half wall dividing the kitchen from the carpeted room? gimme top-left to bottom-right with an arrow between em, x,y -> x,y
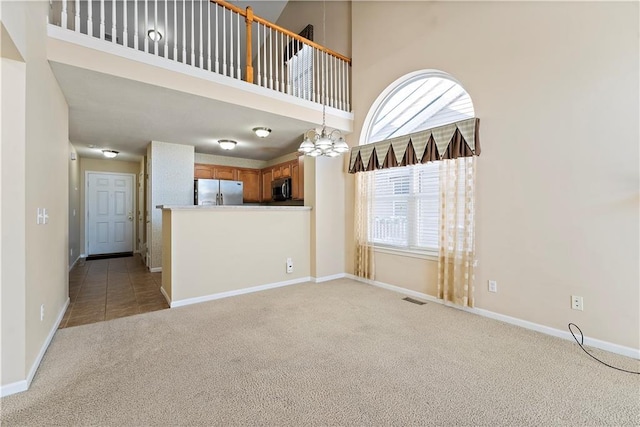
162,207 -> 310,302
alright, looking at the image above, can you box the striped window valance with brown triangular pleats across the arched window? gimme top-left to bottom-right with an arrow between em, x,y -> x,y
349,118 -> 480,173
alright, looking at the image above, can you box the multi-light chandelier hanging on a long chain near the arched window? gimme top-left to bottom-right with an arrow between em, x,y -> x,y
298,1 -> 349,157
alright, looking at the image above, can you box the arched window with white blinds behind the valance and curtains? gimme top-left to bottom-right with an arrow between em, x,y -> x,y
360,70 -> 475,255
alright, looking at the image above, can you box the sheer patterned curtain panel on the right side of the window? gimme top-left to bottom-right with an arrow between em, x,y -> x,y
438,157 -> 476,307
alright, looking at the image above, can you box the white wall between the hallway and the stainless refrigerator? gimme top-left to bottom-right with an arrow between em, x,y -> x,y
147,141 -> 195,270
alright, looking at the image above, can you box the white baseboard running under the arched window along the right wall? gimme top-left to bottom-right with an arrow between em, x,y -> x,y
345,274 -> 640,359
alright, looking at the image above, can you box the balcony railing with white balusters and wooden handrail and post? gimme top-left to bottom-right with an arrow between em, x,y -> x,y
50,0 -> 351,111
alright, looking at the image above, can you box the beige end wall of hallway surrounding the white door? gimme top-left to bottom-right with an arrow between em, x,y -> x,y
80,157 -> 140,255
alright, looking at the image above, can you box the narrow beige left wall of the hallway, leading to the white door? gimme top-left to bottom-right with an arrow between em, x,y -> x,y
68,143 -> 80,268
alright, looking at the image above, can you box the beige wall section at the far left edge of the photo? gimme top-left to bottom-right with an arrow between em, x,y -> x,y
0,16 -> 26,385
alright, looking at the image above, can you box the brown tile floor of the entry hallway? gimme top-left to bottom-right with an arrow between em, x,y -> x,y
60,255 -> 169,328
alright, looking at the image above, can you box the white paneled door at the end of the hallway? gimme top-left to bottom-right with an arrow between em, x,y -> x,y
86,172 -> 134,255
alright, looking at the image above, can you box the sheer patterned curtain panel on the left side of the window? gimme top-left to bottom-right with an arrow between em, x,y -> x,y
354,172 -> 375,280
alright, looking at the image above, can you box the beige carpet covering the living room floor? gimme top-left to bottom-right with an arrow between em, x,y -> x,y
0,280 -> 640,426
